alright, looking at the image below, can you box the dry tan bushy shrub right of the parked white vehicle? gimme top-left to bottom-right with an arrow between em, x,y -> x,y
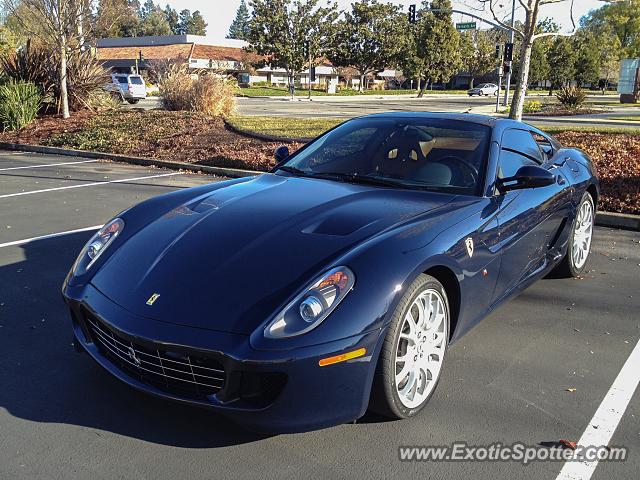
159,65 -> 236,116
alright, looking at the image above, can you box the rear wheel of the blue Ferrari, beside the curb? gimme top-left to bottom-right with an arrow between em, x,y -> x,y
554,193 -> 595,277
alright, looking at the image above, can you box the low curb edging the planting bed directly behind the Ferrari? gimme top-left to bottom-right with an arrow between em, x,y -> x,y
0,142 -> 640,232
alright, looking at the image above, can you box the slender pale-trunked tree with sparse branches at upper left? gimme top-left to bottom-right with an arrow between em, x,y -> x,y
5,0 -> 93,118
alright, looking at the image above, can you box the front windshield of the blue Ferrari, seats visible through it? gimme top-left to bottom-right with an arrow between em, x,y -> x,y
276,118 -> 491,195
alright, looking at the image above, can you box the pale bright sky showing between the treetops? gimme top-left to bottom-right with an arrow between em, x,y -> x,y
160,0 -> 603,39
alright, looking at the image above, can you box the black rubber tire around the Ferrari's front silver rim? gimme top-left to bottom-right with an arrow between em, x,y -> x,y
369,274 -> 450,419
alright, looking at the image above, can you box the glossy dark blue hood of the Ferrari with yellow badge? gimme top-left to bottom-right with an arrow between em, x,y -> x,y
92,174 -> 454,334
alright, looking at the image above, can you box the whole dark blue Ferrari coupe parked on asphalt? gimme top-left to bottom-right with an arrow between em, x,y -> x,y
63,113 -> 599,432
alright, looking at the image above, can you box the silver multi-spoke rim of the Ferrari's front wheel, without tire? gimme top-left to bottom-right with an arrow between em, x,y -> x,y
395,288 -> 449,408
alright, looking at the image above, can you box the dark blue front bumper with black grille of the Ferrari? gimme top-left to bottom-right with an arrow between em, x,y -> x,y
63,285 -> 382,433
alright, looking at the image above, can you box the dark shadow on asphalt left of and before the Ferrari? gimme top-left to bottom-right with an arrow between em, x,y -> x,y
0,232 -> 267,448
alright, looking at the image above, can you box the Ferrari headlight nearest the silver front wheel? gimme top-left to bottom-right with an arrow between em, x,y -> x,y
264,267 -> 356,338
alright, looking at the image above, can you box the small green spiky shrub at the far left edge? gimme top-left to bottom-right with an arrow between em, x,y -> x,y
0,80 -> 42,130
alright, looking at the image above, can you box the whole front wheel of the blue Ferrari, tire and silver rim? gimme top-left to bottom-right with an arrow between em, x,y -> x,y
370,275 -> 450,419
